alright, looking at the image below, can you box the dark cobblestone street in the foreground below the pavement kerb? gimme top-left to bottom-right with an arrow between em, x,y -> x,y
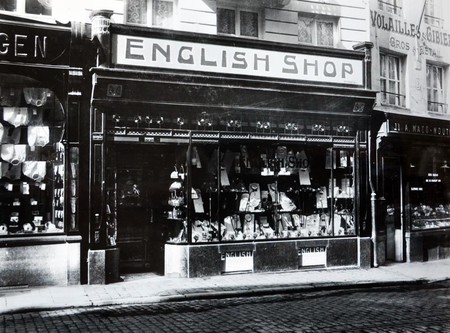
0,282 -> 450,333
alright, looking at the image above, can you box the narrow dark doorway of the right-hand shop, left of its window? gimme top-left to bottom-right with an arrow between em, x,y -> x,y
383,157 -> 405,261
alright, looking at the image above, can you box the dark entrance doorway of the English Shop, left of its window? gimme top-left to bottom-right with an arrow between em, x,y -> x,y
110,144 -> 185,275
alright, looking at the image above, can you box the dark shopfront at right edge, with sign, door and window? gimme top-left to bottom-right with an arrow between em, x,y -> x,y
378,115 -> 450,262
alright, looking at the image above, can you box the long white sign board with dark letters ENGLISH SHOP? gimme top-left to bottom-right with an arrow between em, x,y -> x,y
112,34 -> 363,85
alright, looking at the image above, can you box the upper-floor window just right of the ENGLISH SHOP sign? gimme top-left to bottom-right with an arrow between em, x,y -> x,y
380,53 -> 405,106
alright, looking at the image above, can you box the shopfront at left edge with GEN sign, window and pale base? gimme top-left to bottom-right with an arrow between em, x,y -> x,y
0,15 -> 81,286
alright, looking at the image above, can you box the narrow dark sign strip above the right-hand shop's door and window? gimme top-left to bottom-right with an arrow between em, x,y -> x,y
388,119 -> 450,137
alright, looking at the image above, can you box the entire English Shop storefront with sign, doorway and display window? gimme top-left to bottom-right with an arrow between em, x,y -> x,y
88,11 -> 374,282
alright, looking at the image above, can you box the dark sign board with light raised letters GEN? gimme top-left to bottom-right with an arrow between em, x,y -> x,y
0,20 -> 71,65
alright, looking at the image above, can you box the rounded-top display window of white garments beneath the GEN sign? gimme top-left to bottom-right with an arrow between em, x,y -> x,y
0,74 -> 66,236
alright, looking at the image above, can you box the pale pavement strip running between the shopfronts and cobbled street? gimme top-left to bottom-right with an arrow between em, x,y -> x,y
0,259 -> 450,313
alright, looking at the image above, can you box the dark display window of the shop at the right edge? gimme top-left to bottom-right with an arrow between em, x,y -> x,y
406,147 -> 450,231
